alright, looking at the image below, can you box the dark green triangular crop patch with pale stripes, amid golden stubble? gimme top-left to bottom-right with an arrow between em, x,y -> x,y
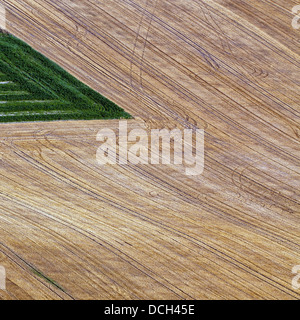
0,32 -> 130,122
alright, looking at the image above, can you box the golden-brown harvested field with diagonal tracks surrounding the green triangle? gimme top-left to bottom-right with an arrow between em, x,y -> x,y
0,0 -> 300,299
